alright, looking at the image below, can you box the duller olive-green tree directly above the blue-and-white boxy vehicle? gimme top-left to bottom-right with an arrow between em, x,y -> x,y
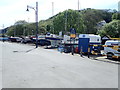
82,9 -> 102,34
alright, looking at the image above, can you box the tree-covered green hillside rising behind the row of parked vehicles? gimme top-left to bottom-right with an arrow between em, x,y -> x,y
7,8 -> 116,36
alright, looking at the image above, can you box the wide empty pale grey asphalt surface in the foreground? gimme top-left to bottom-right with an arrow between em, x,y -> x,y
0,42 -> 118,88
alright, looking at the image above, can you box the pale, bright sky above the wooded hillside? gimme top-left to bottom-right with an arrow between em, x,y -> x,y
0,0 -> 119,29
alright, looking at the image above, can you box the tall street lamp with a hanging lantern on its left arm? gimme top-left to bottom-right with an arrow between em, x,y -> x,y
26,2 -> 38,48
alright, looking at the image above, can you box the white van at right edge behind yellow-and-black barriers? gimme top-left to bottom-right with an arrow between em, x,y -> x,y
104,40 -> 120,59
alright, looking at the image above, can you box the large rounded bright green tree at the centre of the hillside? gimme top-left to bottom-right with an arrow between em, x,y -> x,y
53,9 -> 83,34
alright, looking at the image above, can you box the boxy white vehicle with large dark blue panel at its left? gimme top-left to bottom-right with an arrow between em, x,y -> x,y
78,34 -> 101,53
